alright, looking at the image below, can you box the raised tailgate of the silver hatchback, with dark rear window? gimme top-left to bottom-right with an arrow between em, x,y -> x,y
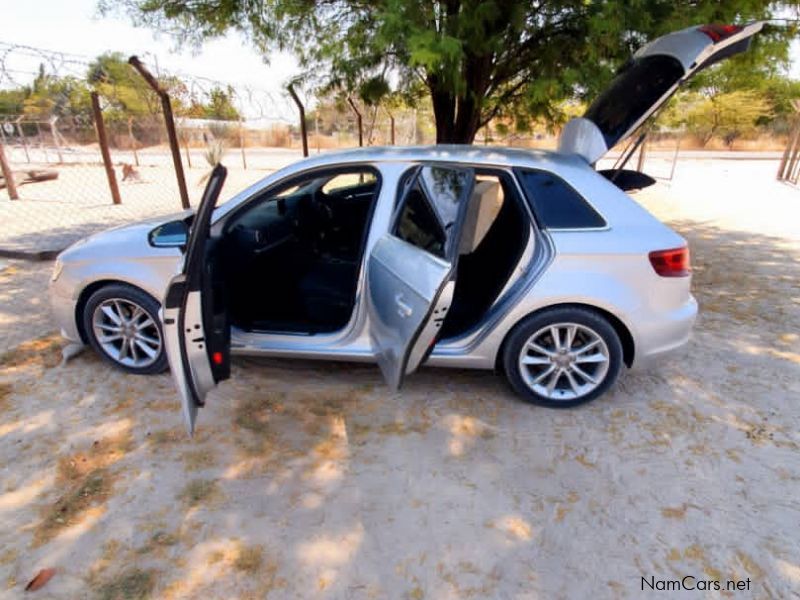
558,23 -> 763,164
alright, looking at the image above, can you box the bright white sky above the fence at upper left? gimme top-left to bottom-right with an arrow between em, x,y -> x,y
0,0 -> 299,91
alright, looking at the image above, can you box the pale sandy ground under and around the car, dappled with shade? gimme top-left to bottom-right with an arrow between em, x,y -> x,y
0,161 -> 800,599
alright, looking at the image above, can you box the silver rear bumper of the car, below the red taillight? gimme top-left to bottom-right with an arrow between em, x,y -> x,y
631,296 -> 698,370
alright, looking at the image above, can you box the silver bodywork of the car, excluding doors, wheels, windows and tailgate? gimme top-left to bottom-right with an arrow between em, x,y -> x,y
51,146 -> 697,394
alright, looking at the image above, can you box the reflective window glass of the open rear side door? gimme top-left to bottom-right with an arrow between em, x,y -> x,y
393,167 -> 470,258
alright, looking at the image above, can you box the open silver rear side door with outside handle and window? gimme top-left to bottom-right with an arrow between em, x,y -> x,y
367,164 -> 475,389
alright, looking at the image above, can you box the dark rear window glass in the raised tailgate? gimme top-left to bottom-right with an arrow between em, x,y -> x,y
584,54 -> 684,148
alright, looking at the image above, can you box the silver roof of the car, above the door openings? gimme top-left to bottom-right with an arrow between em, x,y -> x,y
282,144 -> 588,170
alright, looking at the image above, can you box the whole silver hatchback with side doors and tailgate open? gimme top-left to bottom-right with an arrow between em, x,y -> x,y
51,24 -> 761,432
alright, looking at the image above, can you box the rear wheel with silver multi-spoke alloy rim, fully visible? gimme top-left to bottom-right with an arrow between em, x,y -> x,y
502,307 -> 622,408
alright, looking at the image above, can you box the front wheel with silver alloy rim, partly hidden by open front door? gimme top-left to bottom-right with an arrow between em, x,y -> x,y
82,284 -> 168,375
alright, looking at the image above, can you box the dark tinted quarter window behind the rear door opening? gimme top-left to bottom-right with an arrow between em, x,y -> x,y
517,169 -> 606,229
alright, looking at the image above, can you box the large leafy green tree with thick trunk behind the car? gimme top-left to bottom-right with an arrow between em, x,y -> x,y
106,0 -> 800,143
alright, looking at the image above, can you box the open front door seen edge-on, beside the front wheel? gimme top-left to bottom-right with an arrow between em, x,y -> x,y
163,165 -> 230,435
